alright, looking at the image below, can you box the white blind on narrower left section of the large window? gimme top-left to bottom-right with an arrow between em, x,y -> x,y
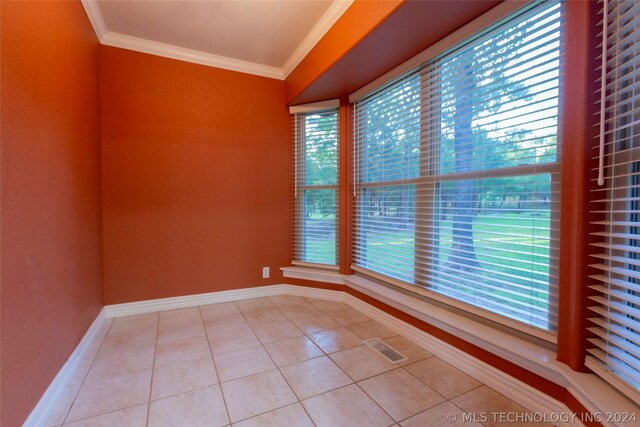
354,73 -> 420,283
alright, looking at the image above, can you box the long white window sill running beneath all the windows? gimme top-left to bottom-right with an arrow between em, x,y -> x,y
281,267 -> 637,420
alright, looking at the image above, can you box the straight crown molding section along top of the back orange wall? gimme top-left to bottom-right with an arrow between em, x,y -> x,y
101,31 -> 284,80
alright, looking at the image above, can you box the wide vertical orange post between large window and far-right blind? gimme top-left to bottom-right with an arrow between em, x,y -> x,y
557,2 -> 597,372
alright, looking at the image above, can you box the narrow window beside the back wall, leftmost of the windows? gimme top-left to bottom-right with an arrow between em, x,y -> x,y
293,108 -> 339,267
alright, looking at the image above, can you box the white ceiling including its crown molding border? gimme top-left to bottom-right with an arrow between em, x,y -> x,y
83,0 -> 353,79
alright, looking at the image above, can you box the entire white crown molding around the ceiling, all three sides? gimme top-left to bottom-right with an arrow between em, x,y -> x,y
82,0 -> 354,80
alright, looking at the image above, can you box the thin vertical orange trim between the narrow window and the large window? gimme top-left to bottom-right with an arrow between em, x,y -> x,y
338,98 -> 353,274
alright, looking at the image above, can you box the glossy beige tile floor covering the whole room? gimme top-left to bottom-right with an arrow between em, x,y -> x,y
48,295 -> 548,427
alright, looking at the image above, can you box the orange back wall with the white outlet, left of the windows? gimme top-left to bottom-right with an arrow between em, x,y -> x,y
101,46 -> 291,304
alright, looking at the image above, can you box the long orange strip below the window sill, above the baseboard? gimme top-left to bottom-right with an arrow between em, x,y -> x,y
296,280 -> 602,427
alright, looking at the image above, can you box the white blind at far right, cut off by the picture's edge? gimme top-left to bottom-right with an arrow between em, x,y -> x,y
587,0 -> 640,404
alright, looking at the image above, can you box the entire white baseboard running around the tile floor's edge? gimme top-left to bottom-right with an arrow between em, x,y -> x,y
24,284 -> 583,427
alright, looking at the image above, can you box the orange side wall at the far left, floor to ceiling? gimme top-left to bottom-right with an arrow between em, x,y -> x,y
0,1 -> 102,427
